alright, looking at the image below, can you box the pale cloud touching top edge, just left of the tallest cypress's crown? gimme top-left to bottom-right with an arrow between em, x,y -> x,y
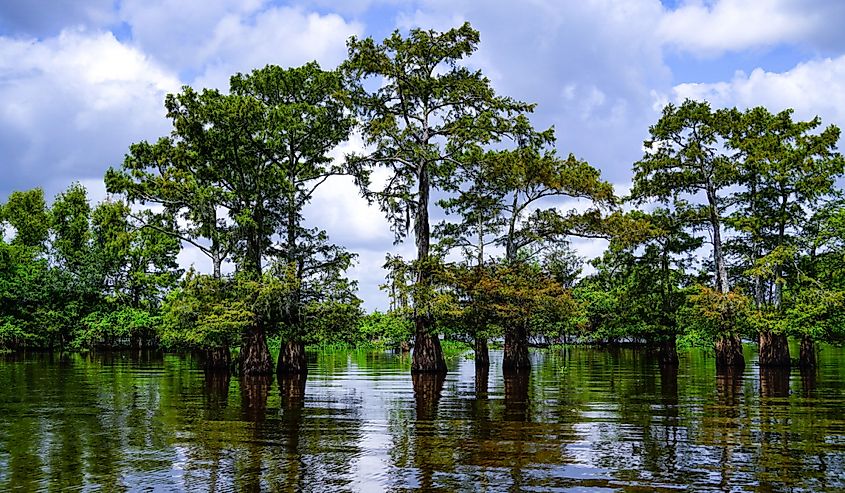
115,0 -> 363,89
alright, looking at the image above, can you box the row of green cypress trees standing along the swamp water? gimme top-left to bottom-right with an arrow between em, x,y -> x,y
0,24 -> 845,374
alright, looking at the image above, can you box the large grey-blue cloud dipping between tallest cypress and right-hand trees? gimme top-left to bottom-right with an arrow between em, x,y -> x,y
397,0 -> 671,184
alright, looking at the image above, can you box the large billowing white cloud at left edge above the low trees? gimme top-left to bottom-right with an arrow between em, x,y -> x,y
0,30 -> 179,195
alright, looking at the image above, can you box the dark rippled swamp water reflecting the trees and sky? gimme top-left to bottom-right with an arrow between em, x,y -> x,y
0,347 -> 845,491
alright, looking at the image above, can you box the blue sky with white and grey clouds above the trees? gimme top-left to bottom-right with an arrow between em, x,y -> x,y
0,0 -> 845,309
